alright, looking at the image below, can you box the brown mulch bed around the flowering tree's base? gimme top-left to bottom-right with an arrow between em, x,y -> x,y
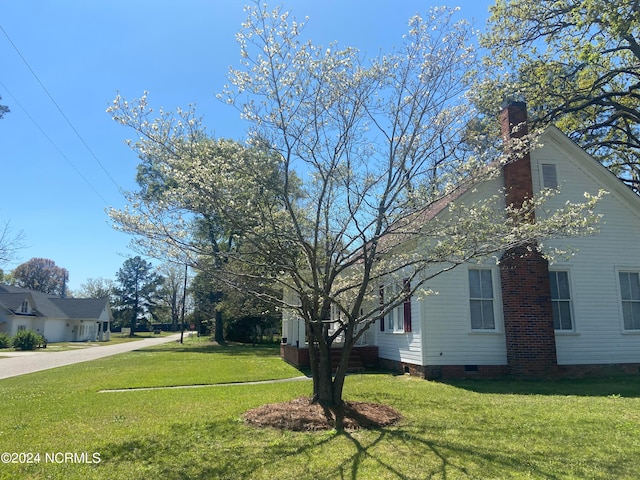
244,397 -> 402,432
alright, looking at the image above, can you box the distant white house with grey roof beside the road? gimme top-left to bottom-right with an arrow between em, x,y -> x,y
0,285 -> 113,342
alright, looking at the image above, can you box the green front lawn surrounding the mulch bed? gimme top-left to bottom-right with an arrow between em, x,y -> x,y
0,338 -> 640,480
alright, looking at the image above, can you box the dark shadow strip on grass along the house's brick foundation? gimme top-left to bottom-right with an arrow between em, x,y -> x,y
440,375 -> 640,398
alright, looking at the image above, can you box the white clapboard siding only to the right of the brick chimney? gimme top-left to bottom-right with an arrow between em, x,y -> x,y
532,136 -> 640,365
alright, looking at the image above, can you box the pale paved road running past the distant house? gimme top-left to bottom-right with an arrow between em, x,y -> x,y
0,334 -> 180,379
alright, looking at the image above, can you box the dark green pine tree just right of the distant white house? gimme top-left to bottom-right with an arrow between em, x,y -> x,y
116,256 -> 163,337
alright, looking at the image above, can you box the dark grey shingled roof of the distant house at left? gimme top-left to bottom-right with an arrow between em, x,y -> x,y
0,284 -> 109,319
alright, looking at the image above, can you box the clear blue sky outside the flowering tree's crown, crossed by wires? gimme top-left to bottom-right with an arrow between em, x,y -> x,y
0,0 -> 493,290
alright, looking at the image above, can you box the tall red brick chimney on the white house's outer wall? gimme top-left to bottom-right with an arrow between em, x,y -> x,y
500,102 -> 557,377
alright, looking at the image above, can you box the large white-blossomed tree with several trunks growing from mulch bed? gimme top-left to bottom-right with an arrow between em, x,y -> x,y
110,2 -> 604,406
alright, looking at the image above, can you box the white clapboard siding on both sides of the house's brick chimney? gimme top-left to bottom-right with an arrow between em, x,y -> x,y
378,125 -> 640,378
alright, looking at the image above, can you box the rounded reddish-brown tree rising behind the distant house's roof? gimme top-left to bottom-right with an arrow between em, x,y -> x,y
13,258 -> 69,296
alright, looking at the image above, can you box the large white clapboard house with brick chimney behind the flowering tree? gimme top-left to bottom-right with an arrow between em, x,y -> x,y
283,103 -> 640,378
